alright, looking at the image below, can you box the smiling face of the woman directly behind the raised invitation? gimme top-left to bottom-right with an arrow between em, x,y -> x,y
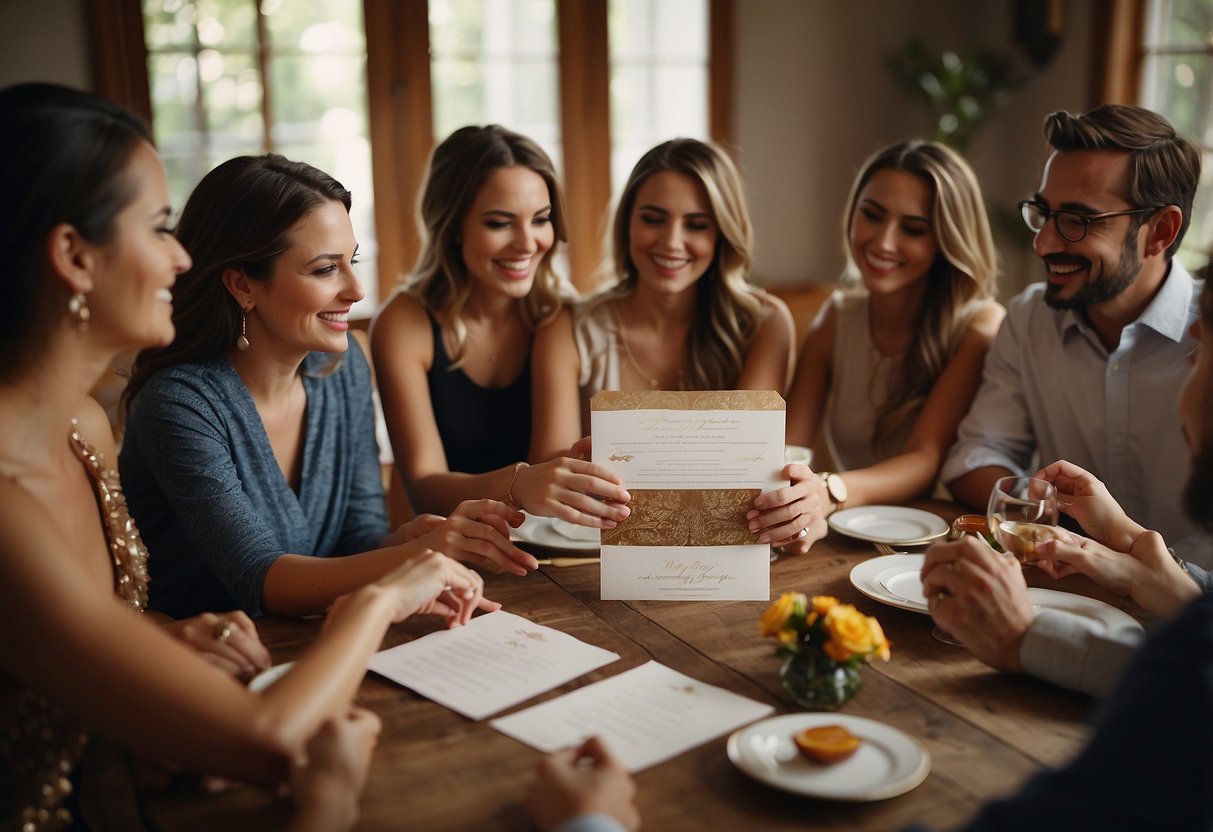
627,171 -> 719,295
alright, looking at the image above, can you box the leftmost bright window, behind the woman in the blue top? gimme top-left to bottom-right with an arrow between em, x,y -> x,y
143,0 -> 378,317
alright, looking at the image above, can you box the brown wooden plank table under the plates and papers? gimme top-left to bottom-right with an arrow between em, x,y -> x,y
148,503 -> 1141,832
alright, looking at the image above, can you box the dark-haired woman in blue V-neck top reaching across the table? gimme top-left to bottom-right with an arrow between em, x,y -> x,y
120,154 -> 537,617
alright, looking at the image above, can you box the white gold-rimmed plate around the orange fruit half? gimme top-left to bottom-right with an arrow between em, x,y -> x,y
728,713 -> 930,800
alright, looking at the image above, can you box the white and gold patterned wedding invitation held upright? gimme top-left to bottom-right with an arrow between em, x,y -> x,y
590,391 -> 787,600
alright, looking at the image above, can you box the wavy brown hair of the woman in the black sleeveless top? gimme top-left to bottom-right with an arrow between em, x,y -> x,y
404,124 -> 569,370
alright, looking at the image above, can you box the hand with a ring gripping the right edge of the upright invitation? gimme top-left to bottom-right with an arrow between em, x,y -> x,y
746,462 -> 830,554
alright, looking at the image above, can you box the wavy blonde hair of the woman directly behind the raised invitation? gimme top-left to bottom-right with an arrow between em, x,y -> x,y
586,138 -> 764,391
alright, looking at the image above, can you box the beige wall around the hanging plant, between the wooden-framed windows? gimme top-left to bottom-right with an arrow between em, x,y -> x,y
734,0 -> 1094,297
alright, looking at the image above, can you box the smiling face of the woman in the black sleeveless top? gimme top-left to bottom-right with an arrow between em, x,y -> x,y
460,165 -> 556,297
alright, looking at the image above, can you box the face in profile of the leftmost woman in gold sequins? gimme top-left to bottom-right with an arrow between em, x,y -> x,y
87,142 -> 190,349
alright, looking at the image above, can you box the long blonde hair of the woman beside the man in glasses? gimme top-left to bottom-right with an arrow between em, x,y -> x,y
843,139 -> 998,449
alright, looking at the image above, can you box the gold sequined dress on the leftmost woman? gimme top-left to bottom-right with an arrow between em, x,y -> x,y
0,422 -> 148,832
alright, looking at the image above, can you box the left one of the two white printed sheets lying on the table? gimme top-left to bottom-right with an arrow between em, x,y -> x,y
370,610 -> 619,719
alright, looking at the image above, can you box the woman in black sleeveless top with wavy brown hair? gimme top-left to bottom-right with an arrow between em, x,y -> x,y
371,125 -> 627,528
